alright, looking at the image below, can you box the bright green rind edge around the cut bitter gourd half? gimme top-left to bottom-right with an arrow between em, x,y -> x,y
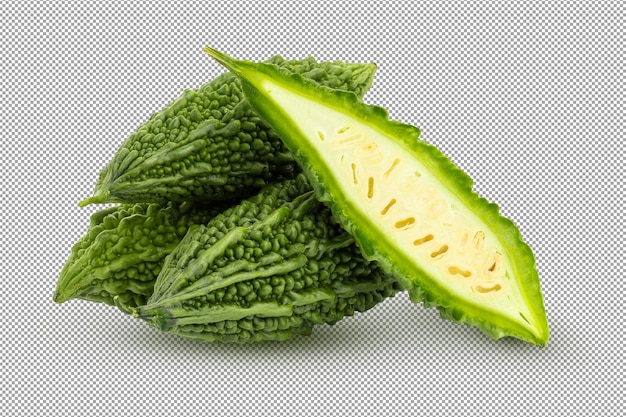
204,48 -> 549,347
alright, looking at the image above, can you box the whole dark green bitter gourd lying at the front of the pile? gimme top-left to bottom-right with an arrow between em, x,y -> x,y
126,174 -> 400,344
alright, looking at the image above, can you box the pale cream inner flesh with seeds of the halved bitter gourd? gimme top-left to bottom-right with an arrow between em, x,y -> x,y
266,80 -> 533,325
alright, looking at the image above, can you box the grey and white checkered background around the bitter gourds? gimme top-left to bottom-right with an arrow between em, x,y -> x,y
0,0 -> 625,416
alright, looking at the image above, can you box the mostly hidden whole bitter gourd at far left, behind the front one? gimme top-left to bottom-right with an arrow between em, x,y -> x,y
53,203 -> 224,306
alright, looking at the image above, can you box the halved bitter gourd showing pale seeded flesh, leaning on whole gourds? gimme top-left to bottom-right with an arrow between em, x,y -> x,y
205,47 -> 549,346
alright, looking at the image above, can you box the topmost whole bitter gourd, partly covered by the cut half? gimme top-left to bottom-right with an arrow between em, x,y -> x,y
79,55 -> 376,206
